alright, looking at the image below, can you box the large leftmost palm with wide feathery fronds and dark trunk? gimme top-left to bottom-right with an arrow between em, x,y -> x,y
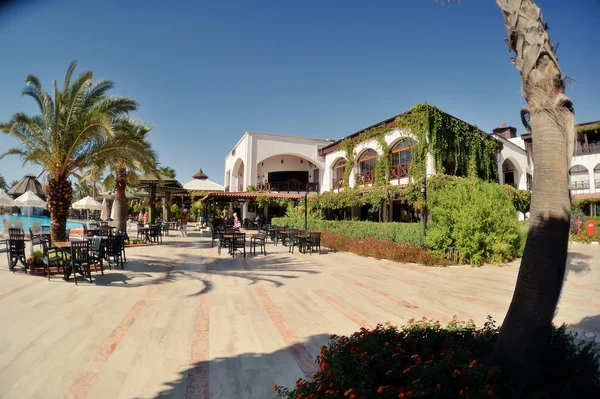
0,62 -> 152,241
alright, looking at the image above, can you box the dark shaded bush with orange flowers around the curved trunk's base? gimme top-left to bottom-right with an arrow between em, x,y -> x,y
273,316 -> 600,399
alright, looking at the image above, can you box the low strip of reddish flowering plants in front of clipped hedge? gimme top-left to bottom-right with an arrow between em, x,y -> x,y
321,231 -> 448,266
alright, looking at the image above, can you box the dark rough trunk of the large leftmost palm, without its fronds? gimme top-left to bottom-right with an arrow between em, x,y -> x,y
46,176 -> 73,242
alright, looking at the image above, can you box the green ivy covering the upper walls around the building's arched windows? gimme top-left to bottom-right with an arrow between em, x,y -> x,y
338,103 -> 500,187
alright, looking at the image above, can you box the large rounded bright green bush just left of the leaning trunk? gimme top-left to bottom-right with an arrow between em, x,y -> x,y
426,178 -> 522,265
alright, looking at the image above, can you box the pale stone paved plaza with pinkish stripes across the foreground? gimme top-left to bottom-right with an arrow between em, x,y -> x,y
0,237 -> 600,399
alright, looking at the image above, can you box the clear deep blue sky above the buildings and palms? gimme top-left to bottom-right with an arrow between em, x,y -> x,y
0,0 -> 600,183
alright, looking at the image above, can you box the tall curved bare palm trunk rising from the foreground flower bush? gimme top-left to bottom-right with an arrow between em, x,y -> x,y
492,0 -> 575,381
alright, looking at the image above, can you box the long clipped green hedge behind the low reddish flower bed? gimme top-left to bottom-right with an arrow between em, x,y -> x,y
271,217 -> 424,245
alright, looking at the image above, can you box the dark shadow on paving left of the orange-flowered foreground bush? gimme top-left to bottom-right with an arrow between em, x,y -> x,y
148,334 -> 329,399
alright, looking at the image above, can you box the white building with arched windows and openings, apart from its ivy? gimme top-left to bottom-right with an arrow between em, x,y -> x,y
211,104 -> 600,220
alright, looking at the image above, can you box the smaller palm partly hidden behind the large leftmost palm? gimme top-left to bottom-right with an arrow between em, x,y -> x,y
91,120 -> 157,231
